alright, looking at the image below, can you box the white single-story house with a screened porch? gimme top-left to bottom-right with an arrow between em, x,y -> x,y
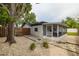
31,22 -> 67,37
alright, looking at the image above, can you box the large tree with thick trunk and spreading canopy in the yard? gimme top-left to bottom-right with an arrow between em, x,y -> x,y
0,3 -> 32,44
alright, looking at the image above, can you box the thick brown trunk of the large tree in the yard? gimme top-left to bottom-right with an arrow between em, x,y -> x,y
5,3 -> 16,44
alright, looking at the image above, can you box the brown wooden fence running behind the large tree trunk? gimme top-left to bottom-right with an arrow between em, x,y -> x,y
0,27 -> 30,37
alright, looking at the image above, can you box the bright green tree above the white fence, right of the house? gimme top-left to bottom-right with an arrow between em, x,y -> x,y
64,17 -> 77,28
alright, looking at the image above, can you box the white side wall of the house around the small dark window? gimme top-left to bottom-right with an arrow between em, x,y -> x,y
31,25 -> 43,37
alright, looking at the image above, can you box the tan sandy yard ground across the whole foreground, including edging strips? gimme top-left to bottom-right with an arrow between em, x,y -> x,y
0,35 -> 79,56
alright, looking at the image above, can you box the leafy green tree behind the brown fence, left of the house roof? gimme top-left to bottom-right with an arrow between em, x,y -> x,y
16,12 -> 36,28
